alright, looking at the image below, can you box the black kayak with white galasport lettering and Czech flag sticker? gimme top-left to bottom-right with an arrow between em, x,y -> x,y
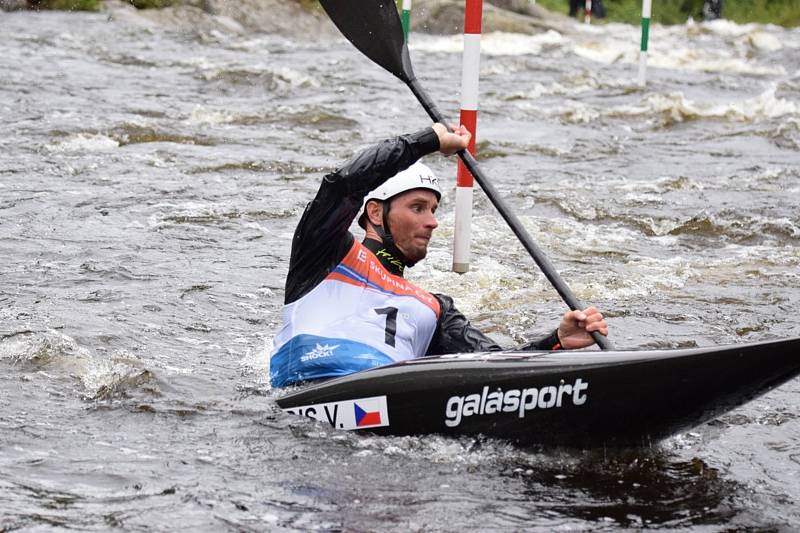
276,338 -> 800,447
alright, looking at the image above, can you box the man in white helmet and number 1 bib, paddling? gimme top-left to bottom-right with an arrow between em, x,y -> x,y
270,124 -> 608,387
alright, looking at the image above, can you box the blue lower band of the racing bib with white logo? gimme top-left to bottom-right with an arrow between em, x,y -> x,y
269,334 -> 394,387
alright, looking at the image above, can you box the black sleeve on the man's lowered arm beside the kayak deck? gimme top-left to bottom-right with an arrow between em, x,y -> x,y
425,294 -> 559,355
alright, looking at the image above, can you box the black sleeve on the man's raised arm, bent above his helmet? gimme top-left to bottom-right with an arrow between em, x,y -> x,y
284,128 -> 439,304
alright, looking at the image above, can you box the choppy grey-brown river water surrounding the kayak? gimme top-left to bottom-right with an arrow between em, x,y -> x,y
0,5 -> 800,531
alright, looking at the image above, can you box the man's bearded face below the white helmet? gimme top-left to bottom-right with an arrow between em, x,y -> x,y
389,189 -> 439,263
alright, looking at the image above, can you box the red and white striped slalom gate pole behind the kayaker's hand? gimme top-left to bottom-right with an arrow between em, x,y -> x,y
453,0 -> 483,274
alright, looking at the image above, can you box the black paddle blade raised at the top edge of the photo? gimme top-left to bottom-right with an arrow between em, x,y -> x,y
319,0 -> 414,83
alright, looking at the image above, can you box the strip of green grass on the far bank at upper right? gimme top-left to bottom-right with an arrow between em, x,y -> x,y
537,0 -> 800,26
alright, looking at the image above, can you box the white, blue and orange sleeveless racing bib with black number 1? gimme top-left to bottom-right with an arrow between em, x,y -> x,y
270,241 -> 440,387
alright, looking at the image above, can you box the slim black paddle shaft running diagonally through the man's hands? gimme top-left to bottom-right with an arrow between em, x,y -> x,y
406,78 -> 612,350
